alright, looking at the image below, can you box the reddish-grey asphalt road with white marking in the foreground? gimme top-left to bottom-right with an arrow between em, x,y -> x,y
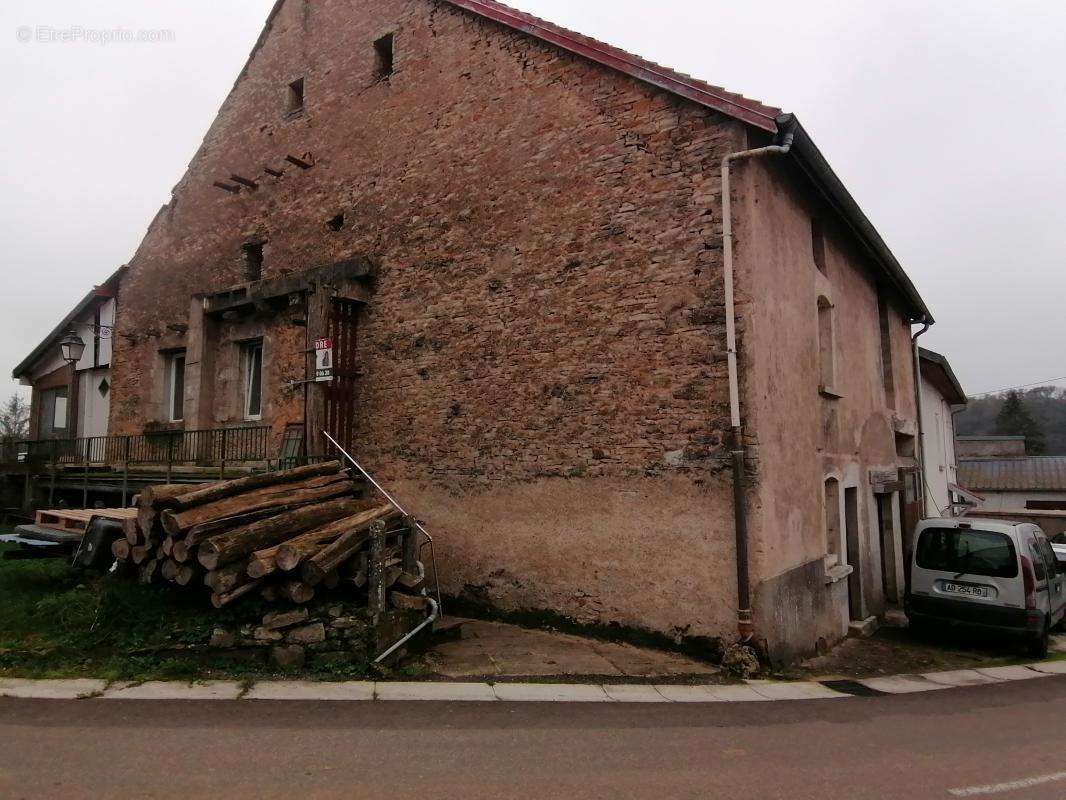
0,677 -> 1066,800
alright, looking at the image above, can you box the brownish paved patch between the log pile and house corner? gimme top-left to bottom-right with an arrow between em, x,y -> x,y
424,618 -> 718,682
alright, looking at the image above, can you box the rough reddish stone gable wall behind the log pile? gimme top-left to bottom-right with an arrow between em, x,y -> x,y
111,0 -> 743,652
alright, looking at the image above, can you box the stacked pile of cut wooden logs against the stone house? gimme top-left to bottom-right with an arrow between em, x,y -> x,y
112,461 -> 425,608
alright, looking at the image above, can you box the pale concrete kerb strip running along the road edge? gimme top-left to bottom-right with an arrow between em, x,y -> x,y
0,660 -> 1066,703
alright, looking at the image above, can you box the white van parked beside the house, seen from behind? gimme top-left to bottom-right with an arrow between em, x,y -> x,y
905,517 -> 1066,658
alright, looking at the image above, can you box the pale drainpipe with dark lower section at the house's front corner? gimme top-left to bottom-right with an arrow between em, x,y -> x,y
722,122 -> 794,642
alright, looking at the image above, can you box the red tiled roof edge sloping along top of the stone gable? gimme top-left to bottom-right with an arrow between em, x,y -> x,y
447,0 -> 781,133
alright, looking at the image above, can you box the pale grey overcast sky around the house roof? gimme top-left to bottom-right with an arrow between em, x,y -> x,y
0,0 -> 1066,401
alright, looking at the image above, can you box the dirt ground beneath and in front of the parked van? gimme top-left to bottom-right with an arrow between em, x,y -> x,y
788,626 -> 1066,679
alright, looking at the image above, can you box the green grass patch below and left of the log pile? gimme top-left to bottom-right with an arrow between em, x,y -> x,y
0,545 -> 366,681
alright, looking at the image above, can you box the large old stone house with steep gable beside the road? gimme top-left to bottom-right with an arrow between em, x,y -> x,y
66,0 -> 932,659
